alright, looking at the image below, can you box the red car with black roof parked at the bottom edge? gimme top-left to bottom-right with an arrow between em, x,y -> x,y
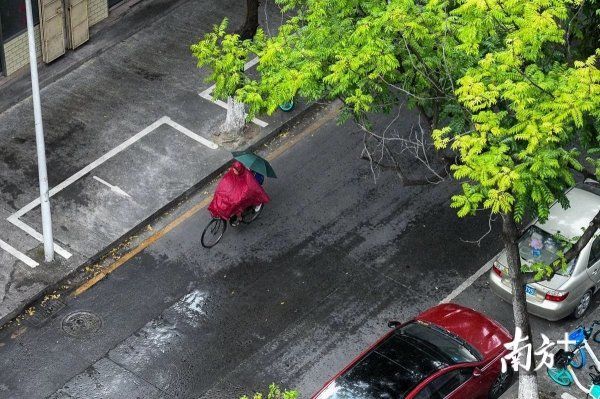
313,303 -> 512,399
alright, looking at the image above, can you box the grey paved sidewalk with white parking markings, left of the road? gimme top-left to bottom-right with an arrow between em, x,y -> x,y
0,0 -> 307,325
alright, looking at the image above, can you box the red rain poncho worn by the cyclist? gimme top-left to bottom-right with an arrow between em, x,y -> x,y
208,161 -> 269,220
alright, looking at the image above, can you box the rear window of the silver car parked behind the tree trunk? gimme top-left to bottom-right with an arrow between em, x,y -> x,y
519,225 -> 575,276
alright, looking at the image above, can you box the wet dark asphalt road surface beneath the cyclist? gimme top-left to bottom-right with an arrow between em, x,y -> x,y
0,114 -> 510,399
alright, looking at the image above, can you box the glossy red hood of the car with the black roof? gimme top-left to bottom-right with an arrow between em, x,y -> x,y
416,303 -> 512,359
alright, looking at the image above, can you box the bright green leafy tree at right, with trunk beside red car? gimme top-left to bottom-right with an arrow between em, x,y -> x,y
434,0 -> 600,398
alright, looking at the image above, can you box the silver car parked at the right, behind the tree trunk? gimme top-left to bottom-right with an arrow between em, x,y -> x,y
490,186 -> 600,321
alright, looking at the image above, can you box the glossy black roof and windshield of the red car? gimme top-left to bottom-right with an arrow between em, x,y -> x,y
317,322 -> 478,399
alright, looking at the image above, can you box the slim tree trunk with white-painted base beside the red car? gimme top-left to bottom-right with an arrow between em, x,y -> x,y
502,213 -> 539,399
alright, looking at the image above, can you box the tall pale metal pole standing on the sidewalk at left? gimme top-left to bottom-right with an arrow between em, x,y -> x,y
24,0 -> 54,262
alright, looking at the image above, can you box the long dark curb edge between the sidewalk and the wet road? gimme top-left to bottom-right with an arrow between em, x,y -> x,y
0,103 -> 327,329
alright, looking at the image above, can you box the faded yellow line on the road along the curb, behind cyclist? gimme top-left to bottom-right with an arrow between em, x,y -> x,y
71,104 -> 339,297
